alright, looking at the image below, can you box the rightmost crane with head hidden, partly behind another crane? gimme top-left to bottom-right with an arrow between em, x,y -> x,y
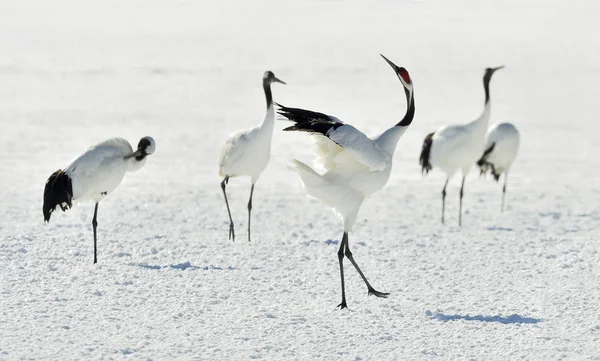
477,123 -> 520,211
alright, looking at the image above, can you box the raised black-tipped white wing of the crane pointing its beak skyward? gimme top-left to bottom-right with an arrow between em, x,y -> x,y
277,104 -> 389,171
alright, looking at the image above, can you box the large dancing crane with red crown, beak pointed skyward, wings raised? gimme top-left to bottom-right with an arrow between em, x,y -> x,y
279,55 -> 415,308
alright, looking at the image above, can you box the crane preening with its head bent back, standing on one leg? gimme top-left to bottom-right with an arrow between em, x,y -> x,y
42,137 -> 156,263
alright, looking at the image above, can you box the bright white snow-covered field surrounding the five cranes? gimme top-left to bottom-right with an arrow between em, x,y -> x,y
0,0 -> 600,360
